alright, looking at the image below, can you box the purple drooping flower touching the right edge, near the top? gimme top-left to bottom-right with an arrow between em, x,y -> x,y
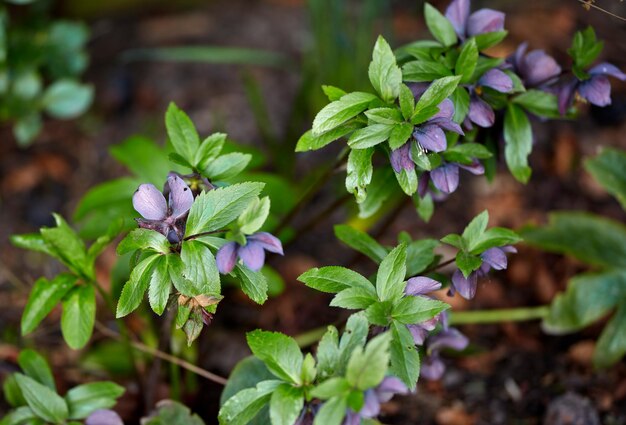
558,62 -> 626,115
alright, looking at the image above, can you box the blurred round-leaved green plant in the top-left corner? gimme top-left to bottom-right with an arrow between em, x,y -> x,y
0,0 -> 93,146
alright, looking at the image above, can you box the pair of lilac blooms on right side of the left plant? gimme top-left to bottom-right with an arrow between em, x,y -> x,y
215,232 -> 283,274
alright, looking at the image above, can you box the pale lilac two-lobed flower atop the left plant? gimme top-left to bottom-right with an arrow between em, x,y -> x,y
133,175 -> 193,243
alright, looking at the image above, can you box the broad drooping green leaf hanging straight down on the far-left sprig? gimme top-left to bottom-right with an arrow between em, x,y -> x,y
61,284 -> 96,350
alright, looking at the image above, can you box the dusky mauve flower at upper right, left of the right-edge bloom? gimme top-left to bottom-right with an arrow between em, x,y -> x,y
507,43 -> 561,87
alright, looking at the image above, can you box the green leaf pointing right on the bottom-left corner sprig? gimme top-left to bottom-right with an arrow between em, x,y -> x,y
65,382 -> 125,419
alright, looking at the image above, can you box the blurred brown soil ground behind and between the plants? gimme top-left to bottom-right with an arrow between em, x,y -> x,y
0,0 -> 626,425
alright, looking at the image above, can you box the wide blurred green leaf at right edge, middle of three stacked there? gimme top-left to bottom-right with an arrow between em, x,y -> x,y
521,212 -> 626,268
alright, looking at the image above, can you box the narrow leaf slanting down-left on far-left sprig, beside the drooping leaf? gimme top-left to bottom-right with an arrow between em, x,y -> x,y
21,274 -> 76,335
